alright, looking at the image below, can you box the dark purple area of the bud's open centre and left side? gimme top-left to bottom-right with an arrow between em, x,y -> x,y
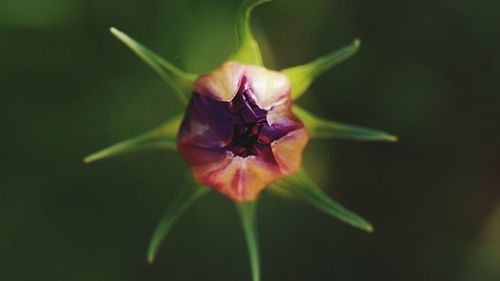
179,76 -> 294,162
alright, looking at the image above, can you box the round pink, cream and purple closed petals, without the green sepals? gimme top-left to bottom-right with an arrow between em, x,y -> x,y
177,61 -> 309,201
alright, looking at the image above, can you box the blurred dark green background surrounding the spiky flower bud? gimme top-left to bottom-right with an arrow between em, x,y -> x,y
0,0 -> 500,281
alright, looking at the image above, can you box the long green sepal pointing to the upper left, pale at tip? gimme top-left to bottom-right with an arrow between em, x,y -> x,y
110,27 -> 197,103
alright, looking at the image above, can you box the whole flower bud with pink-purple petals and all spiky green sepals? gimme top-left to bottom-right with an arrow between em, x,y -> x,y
84,0 -> 397,281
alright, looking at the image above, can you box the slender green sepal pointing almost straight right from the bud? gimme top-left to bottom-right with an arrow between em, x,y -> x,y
292,105 -> 398,142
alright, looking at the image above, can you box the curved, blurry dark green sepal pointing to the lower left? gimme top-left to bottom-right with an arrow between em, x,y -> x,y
147,181 -> 210,264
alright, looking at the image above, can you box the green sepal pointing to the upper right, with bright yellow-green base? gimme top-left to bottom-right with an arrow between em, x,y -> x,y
282,39 -> 361,100
